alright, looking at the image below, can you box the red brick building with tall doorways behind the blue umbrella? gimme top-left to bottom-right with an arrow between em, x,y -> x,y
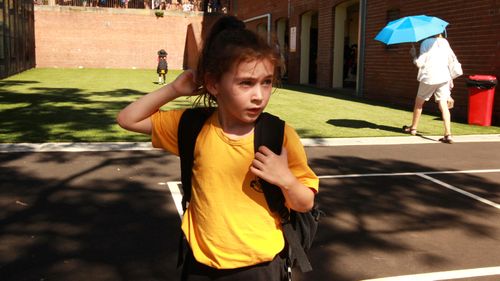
230,0 -> 500,125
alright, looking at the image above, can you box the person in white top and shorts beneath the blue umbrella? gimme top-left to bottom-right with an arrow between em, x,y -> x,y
403,31 -> 455,144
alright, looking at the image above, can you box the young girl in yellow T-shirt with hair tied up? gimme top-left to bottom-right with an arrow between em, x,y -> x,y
117,17 -> 319,281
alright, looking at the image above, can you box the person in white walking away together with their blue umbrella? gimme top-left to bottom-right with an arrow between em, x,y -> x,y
375,15 -> 455,143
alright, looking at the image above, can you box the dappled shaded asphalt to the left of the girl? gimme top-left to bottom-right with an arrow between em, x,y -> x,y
0,151 -> 180,281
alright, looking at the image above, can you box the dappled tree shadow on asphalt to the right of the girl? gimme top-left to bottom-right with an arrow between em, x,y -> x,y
297,156 -> 500,281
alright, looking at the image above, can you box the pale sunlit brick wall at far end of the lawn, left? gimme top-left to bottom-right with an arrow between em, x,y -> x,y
35,6 -> 217,69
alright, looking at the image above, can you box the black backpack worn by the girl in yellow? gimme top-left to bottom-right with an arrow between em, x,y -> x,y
178,108 -> 322,272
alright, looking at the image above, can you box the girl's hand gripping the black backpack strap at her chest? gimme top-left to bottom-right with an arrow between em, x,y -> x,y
250,146 -> 296,188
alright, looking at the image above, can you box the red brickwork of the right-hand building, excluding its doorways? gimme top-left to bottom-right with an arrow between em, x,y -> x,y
235,0 -> 500,125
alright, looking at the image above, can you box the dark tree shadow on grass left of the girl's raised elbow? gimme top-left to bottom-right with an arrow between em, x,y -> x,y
0,84 -> 189,142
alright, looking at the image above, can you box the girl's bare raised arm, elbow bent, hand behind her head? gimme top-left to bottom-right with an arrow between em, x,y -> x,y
116,70 -> 196,135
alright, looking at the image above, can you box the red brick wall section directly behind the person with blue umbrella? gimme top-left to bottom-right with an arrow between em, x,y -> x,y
364,0 -> 500,122
